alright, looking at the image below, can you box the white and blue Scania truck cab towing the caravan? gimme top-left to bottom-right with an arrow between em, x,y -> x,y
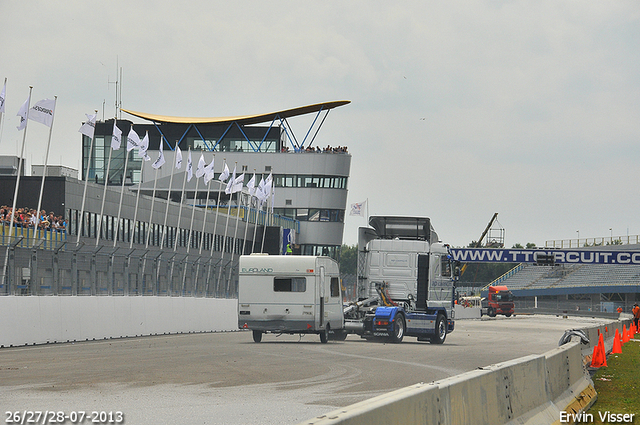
345,216 -> 458,344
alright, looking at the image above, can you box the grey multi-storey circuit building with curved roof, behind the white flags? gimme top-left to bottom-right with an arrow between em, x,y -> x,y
0,101 -> 351,297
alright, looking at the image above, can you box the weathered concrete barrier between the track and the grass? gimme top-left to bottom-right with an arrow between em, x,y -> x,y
298,320 -> 629,425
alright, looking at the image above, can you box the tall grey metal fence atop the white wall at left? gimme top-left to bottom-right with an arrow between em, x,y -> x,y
0,240 -> 240,298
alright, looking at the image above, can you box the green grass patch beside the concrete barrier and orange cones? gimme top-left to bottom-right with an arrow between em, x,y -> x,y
589,341 -> 640,424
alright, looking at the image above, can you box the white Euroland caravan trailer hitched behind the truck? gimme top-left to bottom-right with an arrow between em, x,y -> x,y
238,254 -> 344,343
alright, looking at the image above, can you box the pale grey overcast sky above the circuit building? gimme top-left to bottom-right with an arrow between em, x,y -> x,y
0,0 -> 640,247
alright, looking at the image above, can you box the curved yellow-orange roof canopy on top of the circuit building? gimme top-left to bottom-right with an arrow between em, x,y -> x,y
121,100 -> 351,125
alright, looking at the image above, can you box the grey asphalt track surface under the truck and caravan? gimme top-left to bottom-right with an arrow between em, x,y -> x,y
0,316 -> 608,425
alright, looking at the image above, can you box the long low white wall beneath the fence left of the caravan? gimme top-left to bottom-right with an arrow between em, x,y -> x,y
0,296 -> 238,347
